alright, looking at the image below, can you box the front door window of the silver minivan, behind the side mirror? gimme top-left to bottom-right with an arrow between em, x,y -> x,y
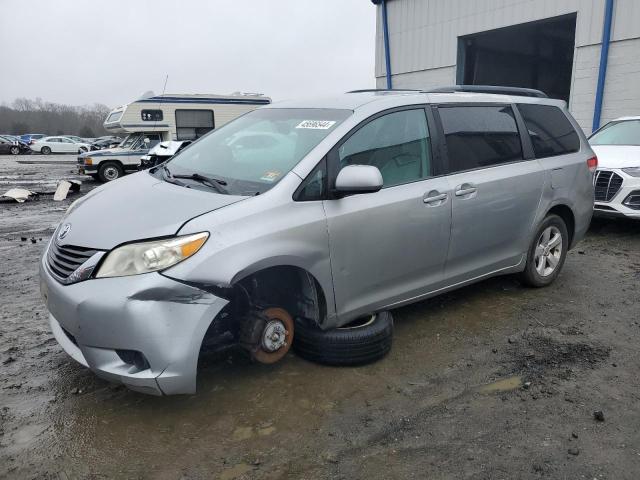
338,109 -> 431,187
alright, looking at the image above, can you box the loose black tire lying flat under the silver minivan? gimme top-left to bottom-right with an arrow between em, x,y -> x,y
293,312 -> 393,365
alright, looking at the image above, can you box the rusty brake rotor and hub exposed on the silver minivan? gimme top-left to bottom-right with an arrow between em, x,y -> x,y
252,307 -> 294,363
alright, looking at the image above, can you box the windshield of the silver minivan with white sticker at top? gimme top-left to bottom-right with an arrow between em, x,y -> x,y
162,108 -> 352,195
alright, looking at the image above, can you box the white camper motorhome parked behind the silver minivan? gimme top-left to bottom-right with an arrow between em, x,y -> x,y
78,94 -> 271,182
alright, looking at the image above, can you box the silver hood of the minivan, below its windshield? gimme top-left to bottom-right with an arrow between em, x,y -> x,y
61,171 -> 247,250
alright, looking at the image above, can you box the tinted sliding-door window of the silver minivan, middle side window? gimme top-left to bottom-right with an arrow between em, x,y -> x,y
438,105 -> 523,173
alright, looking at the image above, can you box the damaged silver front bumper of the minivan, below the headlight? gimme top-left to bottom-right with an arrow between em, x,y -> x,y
40,255 -> 227,395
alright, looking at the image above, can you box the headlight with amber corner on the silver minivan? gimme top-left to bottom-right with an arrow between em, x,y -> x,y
96,232 -> 209,278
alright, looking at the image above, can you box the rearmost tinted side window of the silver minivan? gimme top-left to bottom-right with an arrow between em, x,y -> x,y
518,103 -> 580,158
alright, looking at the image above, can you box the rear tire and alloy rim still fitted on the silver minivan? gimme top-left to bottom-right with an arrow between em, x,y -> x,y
519,214 -> 569,288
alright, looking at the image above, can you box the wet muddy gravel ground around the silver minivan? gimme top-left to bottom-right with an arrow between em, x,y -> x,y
0,156 -> 640,480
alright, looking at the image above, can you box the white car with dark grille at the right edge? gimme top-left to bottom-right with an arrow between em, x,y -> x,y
589,117 -> 640,219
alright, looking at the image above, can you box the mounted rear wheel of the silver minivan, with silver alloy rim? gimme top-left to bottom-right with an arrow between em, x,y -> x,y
520,215 -> 569,287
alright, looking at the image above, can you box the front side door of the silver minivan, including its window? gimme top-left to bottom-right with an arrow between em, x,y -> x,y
324,106 -> 451,318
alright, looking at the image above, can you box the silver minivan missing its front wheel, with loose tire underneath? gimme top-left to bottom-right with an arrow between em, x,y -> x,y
40,89 -> 597,394
